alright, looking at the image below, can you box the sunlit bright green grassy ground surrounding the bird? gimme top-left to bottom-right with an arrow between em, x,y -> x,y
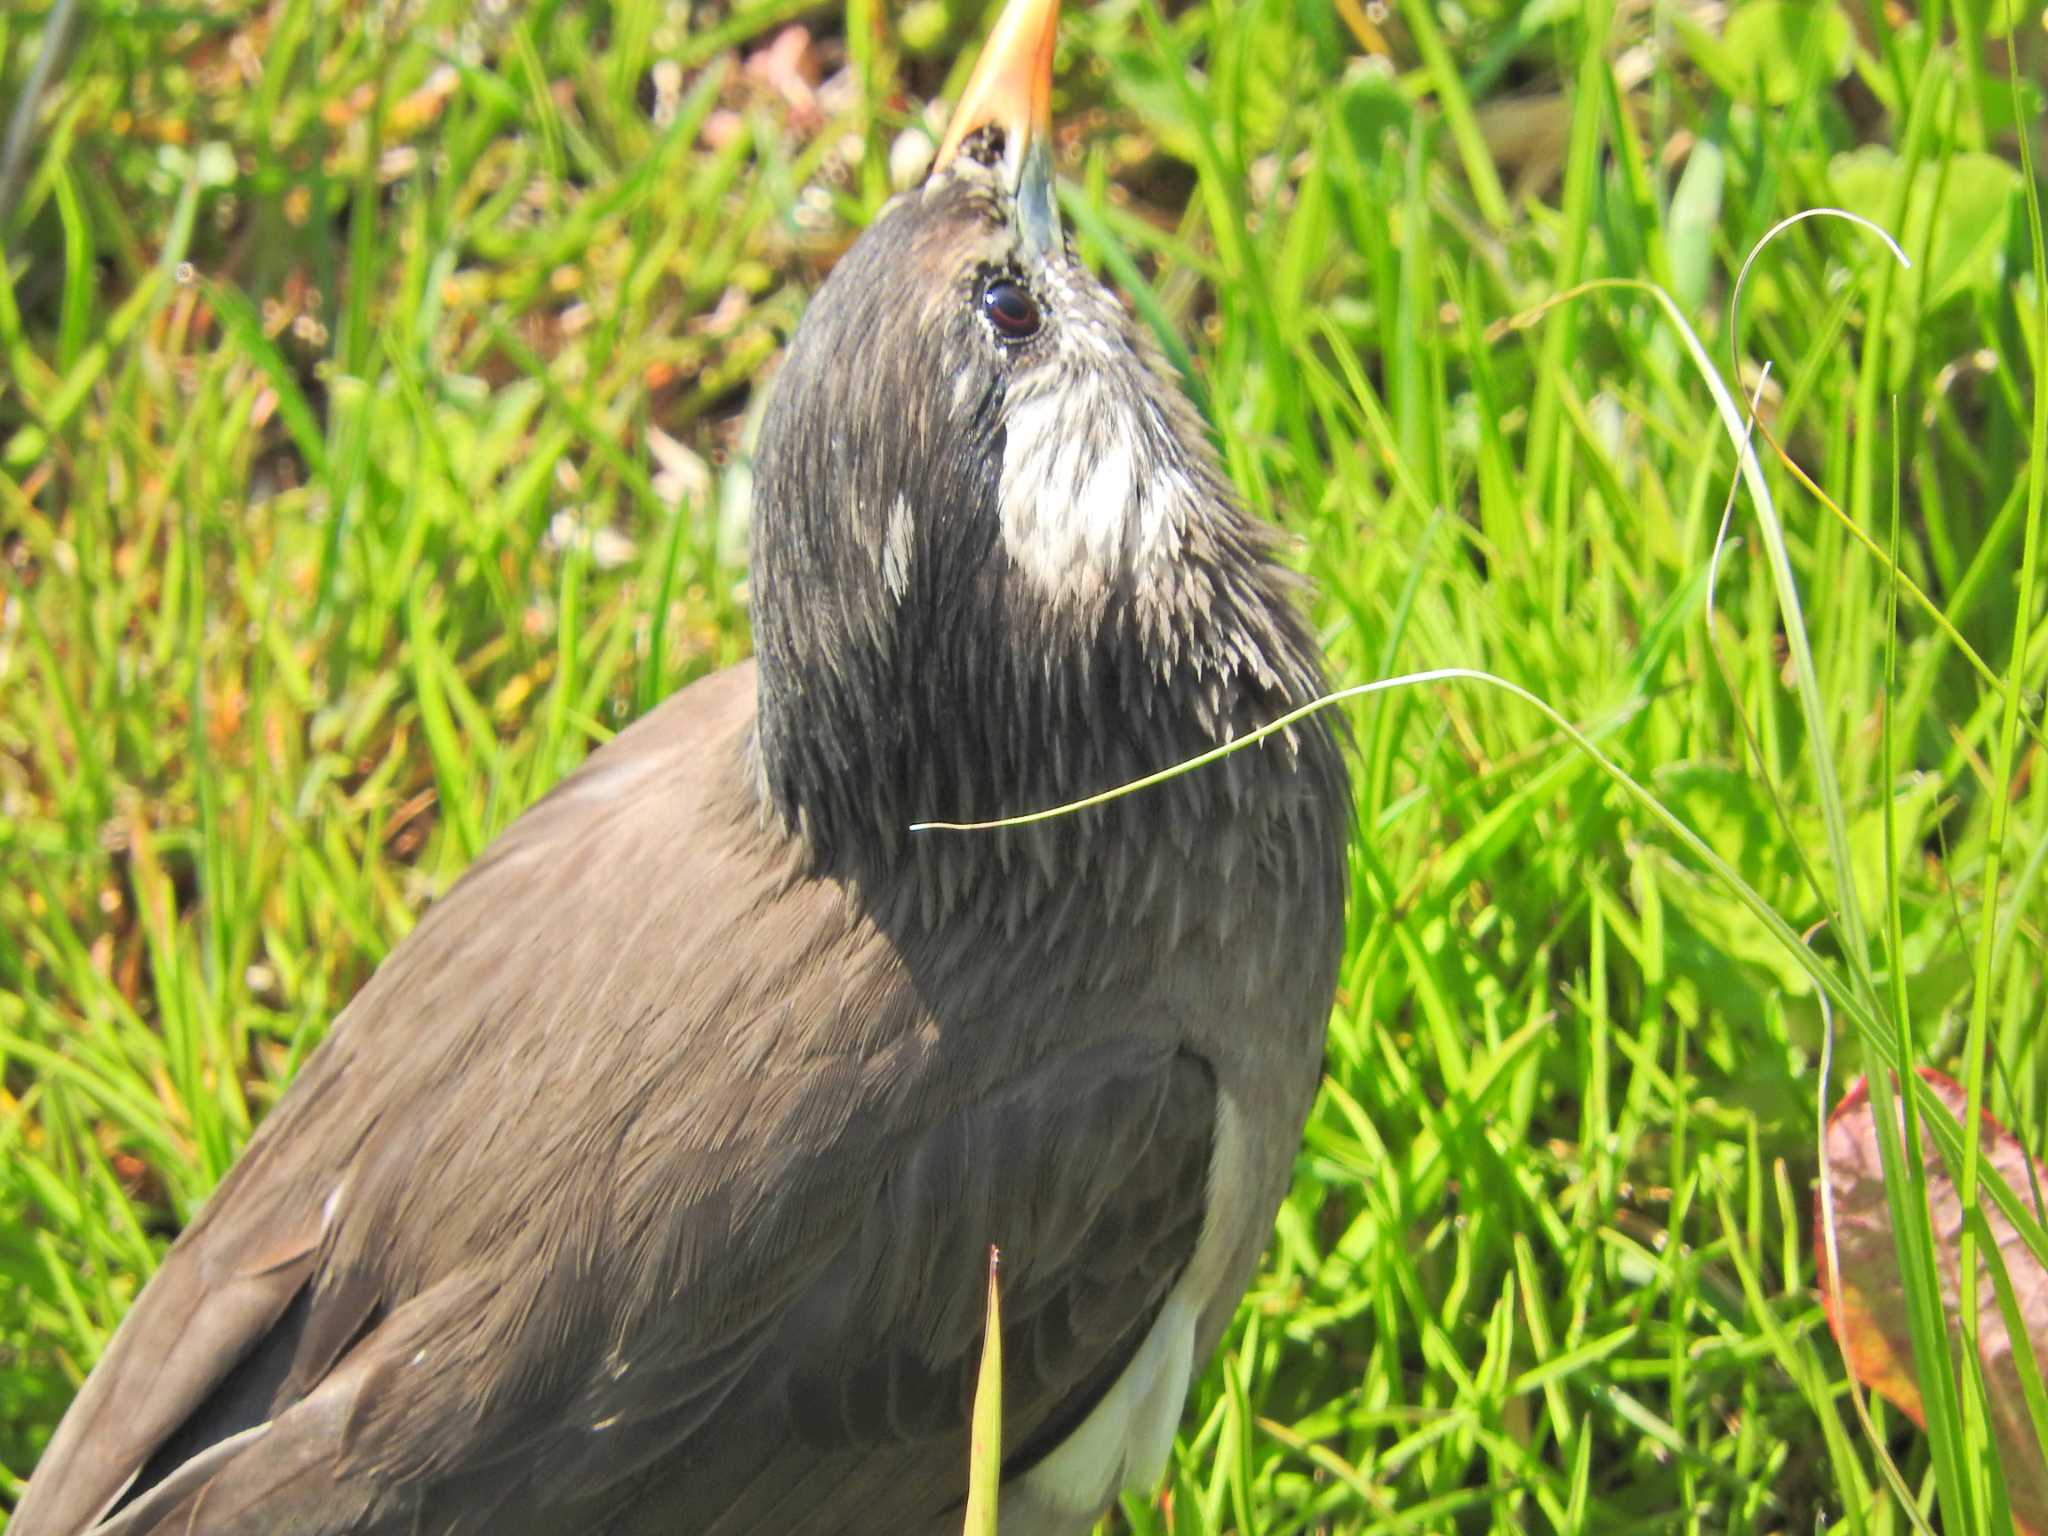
0,0 -> 2048,1536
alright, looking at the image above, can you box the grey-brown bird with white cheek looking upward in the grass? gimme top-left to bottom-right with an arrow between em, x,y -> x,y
10,0 -> 1352,1536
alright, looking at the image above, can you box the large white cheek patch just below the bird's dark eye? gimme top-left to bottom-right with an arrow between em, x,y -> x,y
997,375 -> 1192,594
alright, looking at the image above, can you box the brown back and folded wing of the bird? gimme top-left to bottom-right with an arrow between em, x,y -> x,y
14,668 -> 1217,1536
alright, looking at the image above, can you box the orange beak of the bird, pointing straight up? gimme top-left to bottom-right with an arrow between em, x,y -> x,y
932,0 -> 1059,252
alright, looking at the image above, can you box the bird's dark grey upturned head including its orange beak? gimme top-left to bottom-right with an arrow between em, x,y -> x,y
752,0 -> 1319,876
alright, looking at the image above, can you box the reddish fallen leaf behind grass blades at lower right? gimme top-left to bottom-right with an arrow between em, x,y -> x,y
1815,1067 -> 2048,1536
